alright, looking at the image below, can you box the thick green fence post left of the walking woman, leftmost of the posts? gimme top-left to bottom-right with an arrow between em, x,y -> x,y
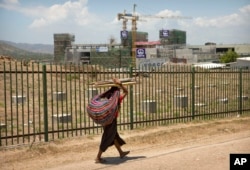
43,64 -> 49,142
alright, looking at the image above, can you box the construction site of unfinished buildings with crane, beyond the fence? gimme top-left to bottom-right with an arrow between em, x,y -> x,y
53,5 -> 250,68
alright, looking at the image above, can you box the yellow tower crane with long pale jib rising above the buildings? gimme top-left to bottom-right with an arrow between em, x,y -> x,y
117,4 -> 191,66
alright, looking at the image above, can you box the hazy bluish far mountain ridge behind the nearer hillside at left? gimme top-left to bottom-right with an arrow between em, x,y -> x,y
0,40 -> 54,54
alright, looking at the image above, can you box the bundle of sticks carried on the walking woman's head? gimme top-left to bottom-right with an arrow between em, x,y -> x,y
90,78 -> 136,87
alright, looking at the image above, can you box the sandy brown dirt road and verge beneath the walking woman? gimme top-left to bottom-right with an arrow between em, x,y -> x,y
0,116 -> 250,170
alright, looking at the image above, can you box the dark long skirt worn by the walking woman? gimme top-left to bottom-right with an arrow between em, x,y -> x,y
100,118 -> 126,152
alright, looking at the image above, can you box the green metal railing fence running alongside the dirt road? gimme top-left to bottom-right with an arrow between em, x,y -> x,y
0,62 -> 250,146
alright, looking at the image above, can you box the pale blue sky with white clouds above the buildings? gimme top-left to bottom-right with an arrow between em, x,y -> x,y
0,0 -> 250,45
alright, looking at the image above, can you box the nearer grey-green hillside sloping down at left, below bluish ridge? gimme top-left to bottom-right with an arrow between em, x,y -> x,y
0,41 -> 53,61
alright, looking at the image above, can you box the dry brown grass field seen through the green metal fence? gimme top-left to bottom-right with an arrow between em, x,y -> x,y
0,58 -> 250,145
